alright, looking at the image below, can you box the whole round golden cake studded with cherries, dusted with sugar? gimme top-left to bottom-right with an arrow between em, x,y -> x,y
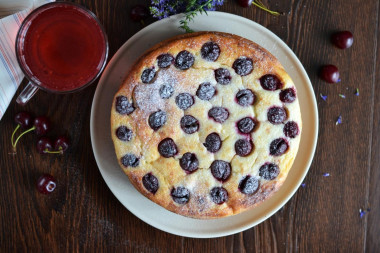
111,32 -> 302,219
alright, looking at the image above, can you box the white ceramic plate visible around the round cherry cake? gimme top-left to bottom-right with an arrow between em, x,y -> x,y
91,12 -> 318,238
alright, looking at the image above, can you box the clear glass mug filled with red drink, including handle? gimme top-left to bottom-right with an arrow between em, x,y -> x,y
16,2 -> 108,105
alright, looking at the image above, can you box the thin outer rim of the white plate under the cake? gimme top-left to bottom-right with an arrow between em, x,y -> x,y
90,11 -> 319,238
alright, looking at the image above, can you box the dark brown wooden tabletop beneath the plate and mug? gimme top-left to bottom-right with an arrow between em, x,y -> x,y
0,0 -> 380,252
